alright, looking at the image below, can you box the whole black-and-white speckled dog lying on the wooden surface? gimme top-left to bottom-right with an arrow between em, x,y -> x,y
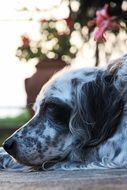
0,55 -> 127,170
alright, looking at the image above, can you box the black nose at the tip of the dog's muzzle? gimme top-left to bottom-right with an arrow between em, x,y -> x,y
3,138 -> 16,155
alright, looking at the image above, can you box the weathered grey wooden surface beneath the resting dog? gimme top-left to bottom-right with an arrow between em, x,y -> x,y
0,169 -> 127,190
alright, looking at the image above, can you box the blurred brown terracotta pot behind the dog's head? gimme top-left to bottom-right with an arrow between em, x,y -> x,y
25,60 -> 66,117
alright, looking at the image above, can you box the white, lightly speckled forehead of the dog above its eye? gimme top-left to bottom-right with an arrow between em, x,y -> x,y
37,68 -> 97,102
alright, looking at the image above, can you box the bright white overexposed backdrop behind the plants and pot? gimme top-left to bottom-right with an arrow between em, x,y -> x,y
0,0 -> 127,116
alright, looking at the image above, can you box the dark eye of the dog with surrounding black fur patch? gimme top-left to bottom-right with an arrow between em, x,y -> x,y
45,103 -> 70,124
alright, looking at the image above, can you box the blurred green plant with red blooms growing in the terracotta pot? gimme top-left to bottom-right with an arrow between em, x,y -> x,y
16,20 -> 77,61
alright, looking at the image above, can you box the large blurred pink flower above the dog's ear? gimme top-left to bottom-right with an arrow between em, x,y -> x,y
94,4 -> 120,43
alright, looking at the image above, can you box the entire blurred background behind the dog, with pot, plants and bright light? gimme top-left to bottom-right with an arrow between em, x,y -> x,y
0,0 -> 127,145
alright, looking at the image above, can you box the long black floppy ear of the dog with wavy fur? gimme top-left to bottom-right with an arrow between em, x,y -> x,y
70,73 -> 123,147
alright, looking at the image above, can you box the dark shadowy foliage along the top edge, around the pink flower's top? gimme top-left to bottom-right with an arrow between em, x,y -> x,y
72,0 -> 127,26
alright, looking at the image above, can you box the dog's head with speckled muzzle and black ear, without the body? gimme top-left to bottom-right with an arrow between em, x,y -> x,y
4,68 -> 122,166
